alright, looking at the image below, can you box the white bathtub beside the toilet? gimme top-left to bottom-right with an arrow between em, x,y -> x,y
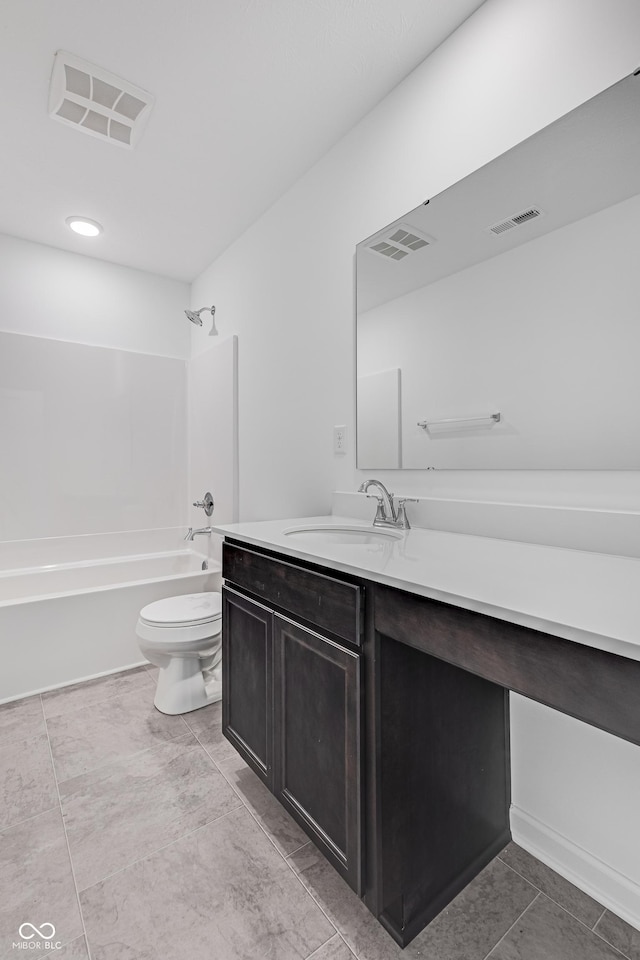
0,538 -> 221,703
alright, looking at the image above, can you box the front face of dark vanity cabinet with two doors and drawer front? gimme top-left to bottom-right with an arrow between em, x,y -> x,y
222,542 -> 362,893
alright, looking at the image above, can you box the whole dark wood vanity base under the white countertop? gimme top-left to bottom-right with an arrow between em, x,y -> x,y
223,535 -> 640,946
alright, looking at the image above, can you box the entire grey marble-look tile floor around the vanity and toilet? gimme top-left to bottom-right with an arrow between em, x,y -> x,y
0,667 -> 640,960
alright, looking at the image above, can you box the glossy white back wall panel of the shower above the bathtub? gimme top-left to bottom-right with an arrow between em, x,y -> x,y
0,333 -> 187,540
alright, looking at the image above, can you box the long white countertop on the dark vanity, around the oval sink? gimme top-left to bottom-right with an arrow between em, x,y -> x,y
213,516 -> 640,660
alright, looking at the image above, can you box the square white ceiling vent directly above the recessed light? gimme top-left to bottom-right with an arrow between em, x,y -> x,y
49,50 -> 153,148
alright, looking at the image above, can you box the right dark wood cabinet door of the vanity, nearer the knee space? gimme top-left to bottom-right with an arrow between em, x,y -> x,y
274,615 -> 362,893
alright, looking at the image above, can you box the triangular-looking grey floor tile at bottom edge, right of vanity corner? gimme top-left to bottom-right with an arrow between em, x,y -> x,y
489,893 -> 620,960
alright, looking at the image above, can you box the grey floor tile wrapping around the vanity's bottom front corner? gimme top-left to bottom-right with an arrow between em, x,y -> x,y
288,844 -> 538,960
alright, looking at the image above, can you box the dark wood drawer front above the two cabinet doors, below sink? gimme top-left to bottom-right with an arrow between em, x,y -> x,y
222,542 -> 361,644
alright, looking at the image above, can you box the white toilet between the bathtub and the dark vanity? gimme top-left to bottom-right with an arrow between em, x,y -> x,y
136,593 -> 222,715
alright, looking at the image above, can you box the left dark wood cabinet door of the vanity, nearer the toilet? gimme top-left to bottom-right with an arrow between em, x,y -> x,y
222,587 -> 273,789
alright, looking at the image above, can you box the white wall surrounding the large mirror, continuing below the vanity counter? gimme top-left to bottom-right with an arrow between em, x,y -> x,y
192,0 -> 640,924
